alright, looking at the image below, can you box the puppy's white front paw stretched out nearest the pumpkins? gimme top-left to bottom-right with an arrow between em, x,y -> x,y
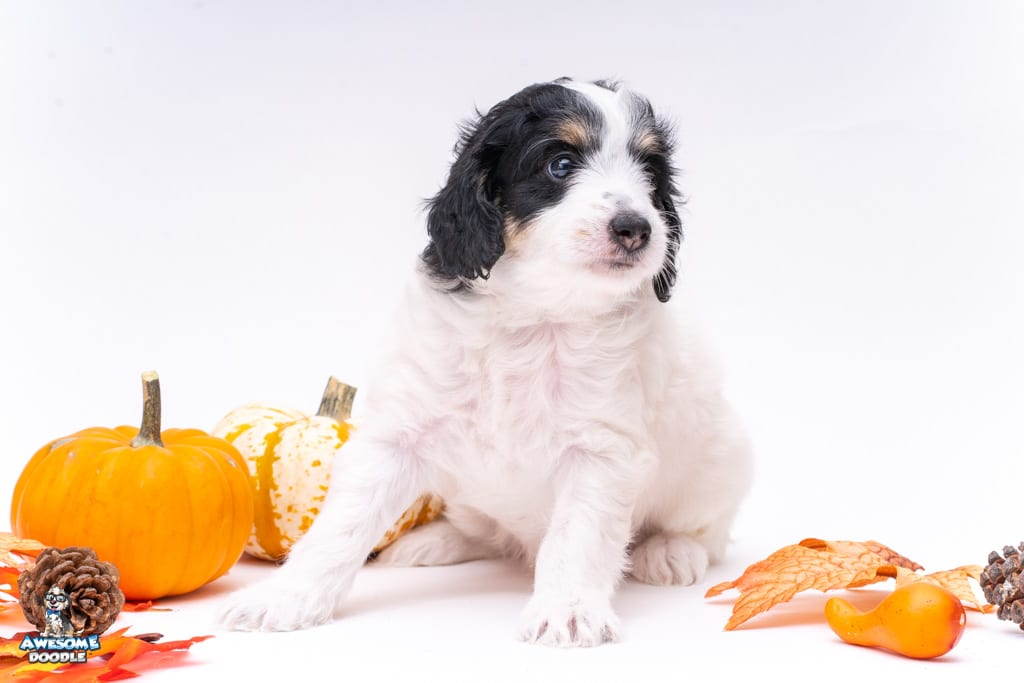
217,578 -> 336,631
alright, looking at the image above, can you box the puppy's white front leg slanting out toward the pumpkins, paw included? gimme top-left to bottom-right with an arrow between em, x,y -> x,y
219,433 -> 425,631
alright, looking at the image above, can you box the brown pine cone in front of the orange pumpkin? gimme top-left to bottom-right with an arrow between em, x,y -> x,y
17,547 -> 125,636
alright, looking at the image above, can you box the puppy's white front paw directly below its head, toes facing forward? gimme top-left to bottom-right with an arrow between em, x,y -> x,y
520,595 -> 618,647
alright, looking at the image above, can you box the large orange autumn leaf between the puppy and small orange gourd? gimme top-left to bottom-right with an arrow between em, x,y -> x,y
705,539 -> 923,631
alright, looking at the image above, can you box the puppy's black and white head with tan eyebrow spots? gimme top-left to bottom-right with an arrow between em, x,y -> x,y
423,79 -> 681,301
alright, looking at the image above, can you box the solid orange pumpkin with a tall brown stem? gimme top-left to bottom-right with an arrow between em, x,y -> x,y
10,373 -> 253,600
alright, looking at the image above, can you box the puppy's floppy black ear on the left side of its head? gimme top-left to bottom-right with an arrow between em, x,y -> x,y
423,111 -> 507,281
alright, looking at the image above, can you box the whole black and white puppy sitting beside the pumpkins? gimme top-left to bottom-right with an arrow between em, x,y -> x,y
221,79 -> 752,646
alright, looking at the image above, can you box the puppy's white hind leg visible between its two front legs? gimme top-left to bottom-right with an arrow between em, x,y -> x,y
374,517 -> 499,566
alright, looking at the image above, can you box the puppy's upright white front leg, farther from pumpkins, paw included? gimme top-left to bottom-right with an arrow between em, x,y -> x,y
521,450 -> 640,647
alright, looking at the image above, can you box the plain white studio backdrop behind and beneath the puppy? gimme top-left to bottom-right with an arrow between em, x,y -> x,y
0,0 -> 1024,680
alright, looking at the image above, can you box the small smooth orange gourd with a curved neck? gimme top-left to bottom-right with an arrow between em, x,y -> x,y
825,582 -> 967,659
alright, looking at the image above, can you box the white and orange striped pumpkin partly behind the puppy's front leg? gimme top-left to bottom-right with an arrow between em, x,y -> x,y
212,377 -> 443,560
